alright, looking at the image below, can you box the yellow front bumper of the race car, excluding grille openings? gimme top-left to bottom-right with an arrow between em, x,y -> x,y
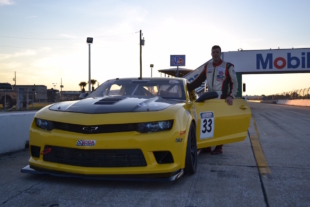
29,116 -> 186,177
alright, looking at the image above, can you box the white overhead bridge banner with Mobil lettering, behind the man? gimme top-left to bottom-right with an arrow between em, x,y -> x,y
222,48 -> 310,73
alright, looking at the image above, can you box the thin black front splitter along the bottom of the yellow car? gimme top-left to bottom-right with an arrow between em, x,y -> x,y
21,165 -> 184,182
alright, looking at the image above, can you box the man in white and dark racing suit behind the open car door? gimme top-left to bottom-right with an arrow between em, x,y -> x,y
187,45 -> 238,155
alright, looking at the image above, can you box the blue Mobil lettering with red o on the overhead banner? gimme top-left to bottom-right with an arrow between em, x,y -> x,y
256,52 -> 310,70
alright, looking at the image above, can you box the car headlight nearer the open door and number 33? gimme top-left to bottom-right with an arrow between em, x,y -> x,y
137,120 -> 173,133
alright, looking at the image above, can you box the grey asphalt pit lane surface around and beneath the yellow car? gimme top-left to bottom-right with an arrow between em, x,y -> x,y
0,103 -> 310,207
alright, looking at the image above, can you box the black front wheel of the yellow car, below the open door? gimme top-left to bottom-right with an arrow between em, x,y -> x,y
184,123 -> 197,175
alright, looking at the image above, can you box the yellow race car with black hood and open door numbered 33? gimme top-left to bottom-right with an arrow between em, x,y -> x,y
21,78 -> 251,181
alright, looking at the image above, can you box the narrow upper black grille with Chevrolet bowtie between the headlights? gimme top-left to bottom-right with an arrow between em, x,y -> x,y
54,122 -> 137,134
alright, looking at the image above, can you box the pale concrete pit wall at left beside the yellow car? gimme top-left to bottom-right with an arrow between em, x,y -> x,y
0,111 -> 36,154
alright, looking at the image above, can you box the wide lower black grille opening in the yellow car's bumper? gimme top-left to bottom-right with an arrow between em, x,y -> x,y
43,146 -> 147,167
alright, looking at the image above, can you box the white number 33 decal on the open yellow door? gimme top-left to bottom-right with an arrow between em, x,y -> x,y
200,112 -> 214,139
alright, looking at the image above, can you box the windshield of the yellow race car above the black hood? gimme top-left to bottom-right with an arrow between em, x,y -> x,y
88,79 -> 186,100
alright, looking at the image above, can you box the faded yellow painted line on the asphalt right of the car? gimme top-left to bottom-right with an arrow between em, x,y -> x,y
249,117 -> 271,175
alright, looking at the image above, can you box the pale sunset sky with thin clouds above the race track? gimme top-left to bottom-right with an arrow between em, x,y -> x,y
0,0 -> 310,95
